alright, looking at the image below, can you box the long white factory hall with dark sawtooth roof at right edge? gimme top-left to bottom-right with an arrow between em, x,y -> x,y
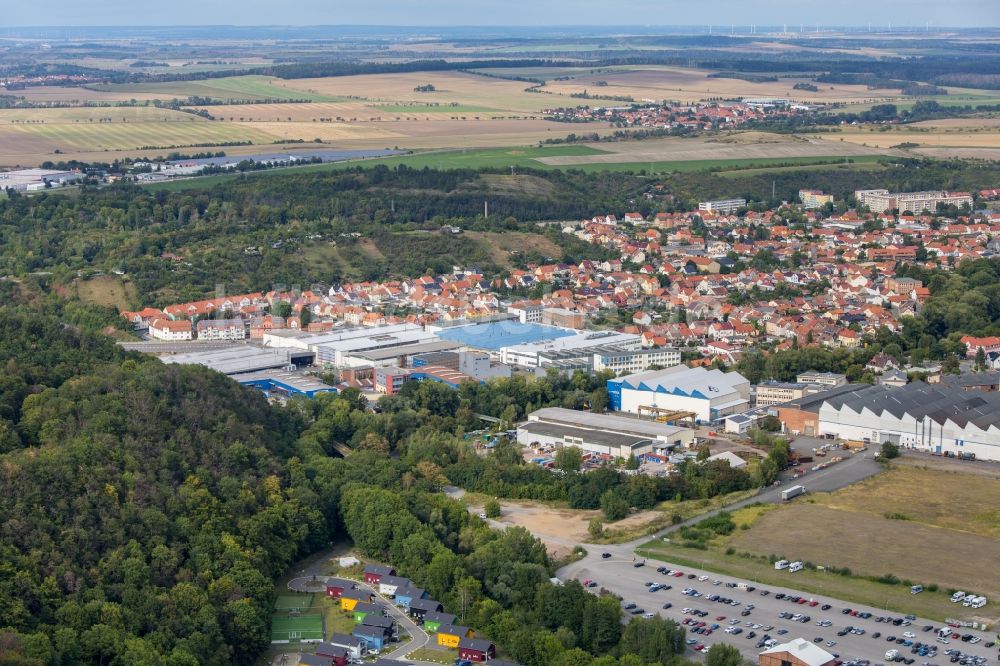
819,382 -> 1000,460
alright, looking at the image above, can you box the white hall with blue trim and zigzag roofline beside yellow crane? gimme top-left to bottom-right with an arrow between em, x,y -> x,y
608,365 -> 750,423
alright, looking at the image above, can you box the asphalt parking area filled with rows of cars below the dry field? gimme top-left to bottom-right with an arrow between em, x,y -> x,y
559,546 -> 997,666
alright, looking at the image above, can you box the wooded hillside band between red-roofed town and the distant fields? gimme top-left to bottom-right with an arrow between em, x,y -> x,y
0,160 -> 1000,305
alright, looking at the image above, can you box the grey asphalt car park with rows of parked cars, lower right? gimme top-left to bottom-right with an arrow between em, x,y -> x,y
560,547 -> 998,666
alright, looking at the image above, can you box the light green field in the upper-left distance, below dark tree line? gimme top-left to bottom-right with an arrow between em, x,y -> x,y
88,76 -> 336,102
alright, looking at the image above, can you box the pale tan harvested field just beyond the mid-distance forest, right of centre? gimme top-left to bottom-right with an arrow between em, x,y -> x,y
539,135 -> 885,166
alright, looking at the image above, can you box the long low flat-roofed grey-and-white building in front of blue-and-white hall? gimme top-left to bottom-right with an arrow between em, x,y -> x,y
517,407 -> 694,458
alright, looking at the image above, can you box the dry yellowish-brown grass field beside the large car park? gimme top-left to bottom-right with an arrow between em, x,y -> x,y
647,467 -> 1000,619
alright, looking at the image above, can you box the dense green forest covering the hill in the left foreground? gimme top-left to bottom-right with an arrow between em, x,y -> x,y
0,294 -> 712,666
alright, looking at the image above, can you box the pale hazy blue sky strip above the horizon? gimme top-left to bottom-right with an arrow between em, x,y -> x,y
7,0 -> 1000,27
